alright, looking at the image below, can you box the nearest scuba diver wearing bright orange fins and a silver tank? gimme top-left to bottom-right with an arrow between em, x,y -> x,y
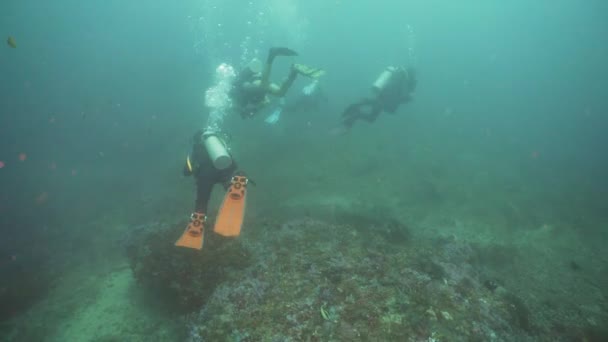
175,130 -> 249,250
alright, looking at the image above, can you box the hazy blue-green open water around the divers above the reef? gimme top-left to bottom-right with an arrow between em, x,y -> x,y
0,0 -> 608,336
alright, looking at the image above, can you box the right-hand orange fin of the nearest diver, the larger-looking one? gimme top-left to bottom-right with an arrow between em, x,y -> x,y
213,176 -> 248,236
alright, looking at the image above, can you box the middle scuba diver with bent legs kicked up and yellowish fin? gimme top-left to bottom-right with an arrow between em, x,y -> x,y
231,47 -> 325,118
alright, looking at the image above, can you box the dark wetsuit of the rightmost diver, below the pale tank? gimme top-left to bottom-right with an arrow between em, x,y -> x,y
342,69 -> 416,128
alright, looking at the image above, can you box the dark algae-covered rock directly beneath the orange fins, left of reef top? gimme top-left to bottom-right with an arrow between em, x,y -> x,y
127,223 -> 249,312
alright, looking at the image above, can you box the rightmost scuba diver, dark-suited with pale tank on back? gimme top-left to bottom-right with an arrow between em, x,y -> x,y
342,67 -> 417,131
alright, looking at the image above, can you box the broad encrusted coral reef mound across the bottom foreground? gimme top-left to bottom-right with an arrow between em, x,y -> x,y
133,216 -> 606,341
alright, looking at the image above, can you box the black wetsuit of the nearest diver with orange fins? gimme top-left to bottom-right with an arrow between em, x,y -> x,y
184,134 -> 237,214
